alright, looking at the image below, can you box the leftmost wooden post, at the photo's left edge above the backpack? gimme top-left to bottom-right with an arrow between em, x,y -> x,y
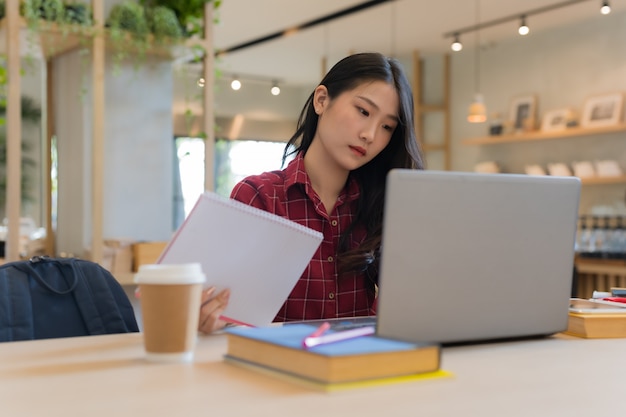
4,1 -> 22,262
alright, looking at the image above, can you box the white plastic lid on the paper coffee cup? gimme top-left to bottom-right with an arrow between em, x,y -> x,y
134,262 -> 206,285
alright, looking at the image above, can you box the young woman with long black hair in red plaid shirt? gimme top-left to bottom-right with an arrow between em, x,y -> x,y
199,53 -> 423,333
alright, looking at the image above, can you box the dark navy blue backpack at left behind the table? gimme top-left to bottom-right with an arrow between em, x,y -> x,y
0,257 -> 139,342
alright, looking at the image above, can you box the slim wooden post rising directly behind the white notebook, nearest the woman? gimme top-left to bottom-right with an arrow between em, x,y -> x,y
202,2 -> 215,190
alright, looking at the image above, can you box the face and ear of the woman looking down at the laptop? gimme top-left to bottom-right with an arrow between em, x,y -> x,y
313,81 -> 400,171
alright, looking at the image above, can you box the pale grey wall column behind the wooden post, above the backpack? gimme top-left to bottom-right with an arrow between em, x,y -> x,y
54,53 -> 174,256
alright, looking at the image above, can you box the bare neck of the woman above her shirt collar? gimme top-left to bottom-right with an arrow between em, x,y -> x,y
304,140 -> 350,213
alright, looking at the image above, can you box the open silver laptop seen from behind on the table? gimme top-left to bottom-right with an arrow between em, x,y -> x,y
377,169 -> 580,344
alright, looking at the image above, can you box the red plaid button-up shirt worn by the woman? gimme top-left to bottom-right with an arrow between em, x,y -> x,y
231,156 -> 375,321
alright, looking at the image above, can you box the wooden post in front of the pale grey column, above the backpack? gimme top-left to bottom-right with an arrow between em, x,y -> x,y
91,0 -> 105,263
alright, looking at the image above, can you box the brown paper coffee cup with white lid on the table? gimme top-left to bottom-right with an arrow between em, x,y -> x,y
135,263 -> 206,362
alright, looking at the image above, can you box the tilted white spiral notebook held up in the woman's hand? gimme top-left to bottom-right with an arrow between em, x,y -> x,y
157,191 -> 323,326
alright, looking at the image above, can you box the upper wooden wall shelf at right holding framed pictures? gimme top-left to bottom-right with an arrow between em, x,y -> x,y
462,124 -> 626,145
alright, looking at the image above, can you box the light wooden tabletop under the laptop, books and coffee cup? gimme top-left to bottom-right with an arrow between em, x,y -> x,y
0,333 -> 626,417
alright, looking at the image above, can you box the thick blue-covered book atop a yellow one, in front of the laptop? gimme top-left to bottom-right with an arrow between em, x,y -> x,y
224,324 -> 450,391
